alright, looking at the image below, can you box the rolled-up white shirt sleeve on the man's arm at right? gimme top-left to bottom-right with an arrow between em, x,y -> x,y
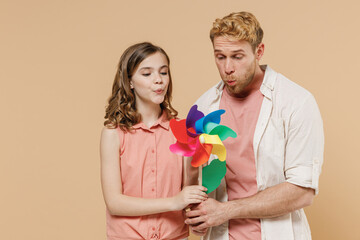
285,95 -> 324,194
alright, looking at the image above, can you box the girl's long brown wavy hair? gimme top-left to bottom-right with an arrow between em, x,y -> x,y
104,42 -> 178,131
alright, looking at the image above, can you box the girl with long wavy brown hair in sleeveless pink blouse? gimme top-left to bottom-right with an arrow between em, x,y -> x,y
100,42 -> 207,240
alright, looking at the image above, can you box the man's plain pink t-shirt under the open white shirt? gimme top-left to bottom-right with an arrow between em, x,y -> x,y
220,88 -> 264,240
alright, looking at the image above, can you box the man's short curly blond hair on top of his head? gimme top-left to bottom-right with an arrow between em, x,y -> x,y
210,12 -> 264,51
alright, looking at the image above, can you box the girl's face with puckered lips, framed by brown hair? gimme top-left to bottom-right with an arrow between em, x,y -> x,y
130,52 -> 169,107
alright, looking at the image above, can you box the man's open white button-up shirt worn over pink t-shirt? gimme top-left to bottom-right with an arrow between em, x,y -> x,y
195,66 -> 324,240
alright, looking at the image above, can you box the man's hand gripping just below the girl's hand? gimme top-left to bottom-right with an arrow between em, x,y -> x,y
185,198 -> 228,232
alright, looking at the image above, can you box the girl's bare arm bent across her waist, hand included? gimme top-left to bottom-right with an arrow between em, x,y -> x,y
100,127 -> 207,216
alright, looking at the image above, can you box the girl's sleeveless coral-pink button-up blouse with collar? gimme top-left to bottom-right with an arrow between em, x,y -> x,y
106,113 -> 189,240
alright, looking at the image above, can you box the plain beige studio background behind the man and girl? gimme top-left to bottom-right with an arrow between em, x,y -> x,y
0,0 -> 360,240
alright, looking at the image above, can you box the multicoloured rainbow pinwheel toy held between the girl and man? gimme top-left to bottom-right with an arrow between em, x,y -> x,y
170,105 -> 237,193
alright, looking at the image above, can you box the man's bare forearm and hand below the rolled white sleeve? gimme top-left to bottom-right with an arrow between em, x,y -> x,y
185,182 -> 315,231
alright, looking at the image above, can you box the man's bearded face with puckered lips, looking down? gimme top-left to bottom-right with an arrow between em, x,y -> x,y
214,36 -> 258,96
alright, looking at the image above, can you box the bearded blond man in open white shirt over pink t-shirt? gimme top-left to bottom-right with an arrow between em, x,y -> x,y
185,12 -> 324,240
